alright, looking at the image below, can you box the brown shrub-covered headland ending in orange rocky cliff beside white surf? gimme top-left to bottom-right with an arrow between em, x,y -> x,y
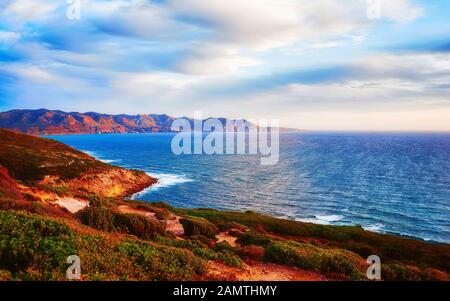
0,129 -> 156,197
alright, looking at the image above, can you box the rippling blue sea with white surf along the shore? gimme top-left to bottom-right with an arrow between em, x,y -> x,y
50,132 -> 450,243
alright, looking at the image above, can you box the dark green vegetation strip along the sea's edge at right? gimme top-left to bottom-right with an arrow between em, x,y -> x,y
177,209 -> 450,273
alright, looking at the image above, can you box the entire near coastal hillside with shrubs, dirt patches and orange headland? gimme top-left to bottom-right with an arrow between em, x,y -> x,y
0,130 -> 450,281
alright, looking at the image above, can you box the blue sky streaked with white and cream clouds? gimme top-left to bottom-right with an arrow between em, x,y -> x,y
0,0 -> 450,131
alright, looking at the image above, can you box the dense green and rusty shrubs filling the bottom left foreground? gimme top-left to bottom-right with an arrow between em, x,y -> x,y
0,211 -> 205,280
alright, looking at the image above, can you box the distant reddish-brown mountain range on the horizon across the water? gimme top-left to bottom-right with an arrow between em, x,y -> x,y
0,109 -> 293,135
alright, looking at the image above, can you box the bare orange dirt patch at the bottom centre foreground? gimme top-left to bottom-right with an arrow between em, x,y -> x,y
208,261 -> 327,281
